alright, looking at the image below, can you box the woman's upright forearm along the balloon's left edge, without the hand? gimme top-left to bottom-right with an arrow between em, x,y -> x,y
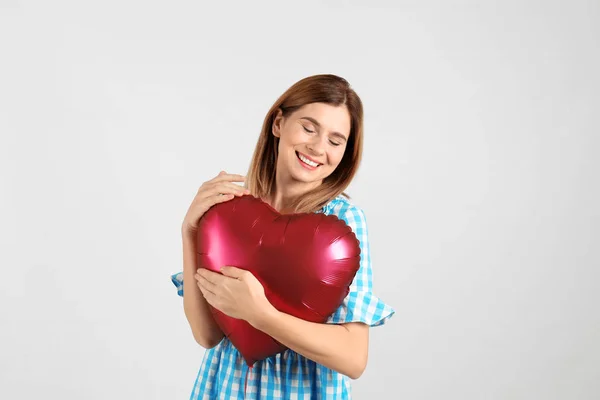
182,232 -> 223,349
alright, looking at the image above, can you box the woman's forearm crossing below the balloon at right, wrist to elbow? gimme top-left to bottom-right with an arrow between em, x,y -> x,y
252,309 -> 369,379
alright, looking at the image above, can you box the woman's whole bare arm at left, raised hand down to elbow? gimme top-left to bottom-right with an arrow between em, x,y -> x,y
181,171 -> 250,349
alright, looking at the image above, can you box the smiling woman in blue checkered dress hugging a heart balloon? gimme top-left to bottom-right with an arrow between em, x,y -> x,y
172,75 -> 394,399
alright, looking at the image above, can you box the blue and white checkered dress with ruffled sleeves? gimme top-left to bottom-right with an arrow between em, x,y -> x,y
171,196 -> 394,400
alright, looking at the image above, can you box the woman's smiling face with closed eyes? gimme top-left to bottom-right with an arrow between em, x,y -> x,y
273,103 -> 350,185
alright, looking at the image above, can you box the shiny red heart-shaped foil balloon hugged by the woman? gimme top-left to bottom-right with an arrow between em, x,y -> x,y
196,195 -> 360,366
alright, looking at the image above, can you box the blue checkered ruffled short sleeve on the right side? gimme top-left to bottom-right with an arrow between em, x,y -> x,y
326,202 -> 395,327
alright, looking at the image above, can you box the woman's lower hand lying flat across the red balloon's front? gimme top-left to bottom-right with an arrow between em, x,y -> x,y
195,267 -> 276,327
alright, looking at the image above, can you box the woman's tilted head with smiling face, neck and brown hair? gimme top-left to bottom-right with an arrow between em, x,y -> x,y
247,75 -> 363,216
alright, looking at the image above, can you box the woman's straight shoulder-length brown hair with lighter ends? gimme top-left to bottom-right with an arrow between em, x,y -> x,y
245,74 -> 363,213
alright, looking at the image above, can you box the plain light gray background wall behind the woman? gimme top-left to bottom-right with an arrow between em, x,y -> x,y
0,0 -> 600,400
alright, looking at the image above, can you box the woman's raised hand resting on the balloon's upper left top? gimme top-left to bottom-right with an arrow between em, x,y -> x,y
181,171 -> 250,235
